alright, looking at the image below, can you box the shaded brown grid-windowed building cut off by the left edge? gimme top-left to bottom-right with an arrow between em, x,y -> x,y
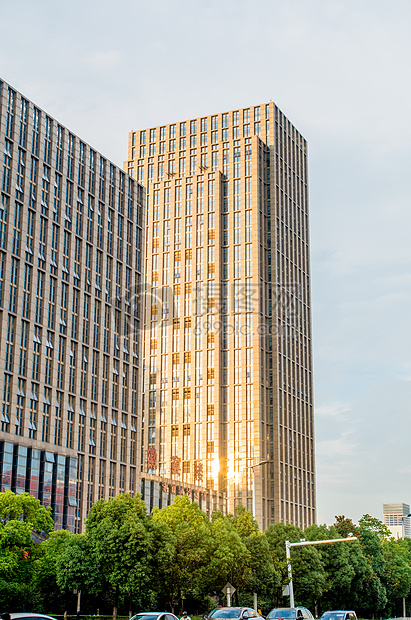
0,81 -> 144,531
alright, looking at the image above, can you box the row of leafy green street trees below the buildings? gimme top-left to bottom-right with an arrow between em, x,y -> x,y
0,491 -> 411,618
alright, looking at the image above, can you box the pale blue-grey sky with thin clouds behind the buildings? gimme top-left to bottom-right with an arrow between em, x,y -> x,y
0,0 -> 411,524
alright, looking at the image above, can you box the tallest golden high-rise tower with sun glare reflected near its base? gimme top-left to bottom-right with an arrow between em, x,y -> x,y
125,103 -> 315,528
